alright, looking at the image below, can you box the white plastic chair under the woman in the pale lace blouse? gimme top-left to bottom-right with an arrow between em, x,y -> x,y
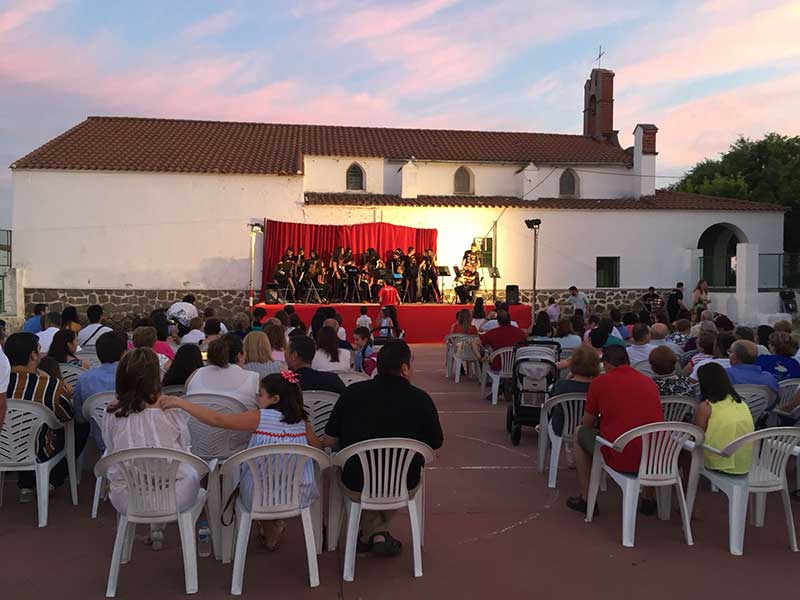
94,448 -> 208,598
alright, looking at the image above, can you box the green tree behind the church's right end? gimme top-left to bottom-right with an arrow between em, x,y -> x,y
668,133 -> 800,252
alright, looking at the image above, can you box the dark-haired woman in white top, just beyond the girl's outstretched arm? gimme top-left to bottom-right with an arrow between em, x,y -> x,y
186,333 -> 259,408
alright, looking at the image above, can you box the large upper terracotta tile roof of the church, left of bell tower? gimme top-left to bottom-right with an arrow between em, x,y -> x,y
11,117 -> 631,175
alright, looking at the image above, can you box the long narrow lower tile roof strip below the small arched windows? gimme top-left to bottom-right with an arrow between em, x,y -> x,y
305,190 -> 786,212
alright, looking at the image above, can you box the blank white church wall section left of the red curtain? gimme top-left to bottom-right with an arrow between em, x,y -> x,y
12,170 -> 303,289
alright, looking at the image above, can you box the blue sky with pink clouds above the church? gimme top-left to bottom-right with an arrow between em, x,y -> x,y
0,0 -> 800,219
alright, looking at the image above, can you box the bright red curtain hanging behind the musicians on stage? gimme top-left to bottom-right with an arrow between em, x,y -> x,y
262,219 -> 438,282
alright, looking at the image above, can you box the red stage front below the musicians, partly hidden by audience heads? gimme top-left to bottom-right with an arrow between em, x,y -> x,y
260,304 -> 531,344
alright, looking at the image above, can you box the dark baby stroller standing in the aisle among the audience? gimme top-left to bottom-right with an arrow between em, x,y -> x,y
506,340 -> 561,446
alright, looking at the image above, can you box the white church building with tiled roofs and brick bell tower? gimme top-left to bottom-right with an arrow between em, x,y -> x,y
3,69 -> 784,320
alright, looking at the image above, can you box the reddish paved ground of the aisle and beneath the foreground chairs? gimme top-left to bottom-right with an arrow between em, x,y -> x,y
0,346 -> 800,600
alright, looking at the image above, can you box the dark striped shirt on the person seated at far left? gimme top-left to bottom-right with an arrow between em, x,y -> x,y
6,370 -> 72,460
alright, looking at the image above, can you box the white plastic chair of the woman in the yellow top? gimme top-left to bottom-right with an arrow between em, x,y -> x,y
688,427 -> 800,556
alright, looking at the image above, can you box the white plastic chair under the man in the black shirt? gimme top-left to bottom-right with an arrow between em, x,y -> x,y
328,438 -> 434,581
